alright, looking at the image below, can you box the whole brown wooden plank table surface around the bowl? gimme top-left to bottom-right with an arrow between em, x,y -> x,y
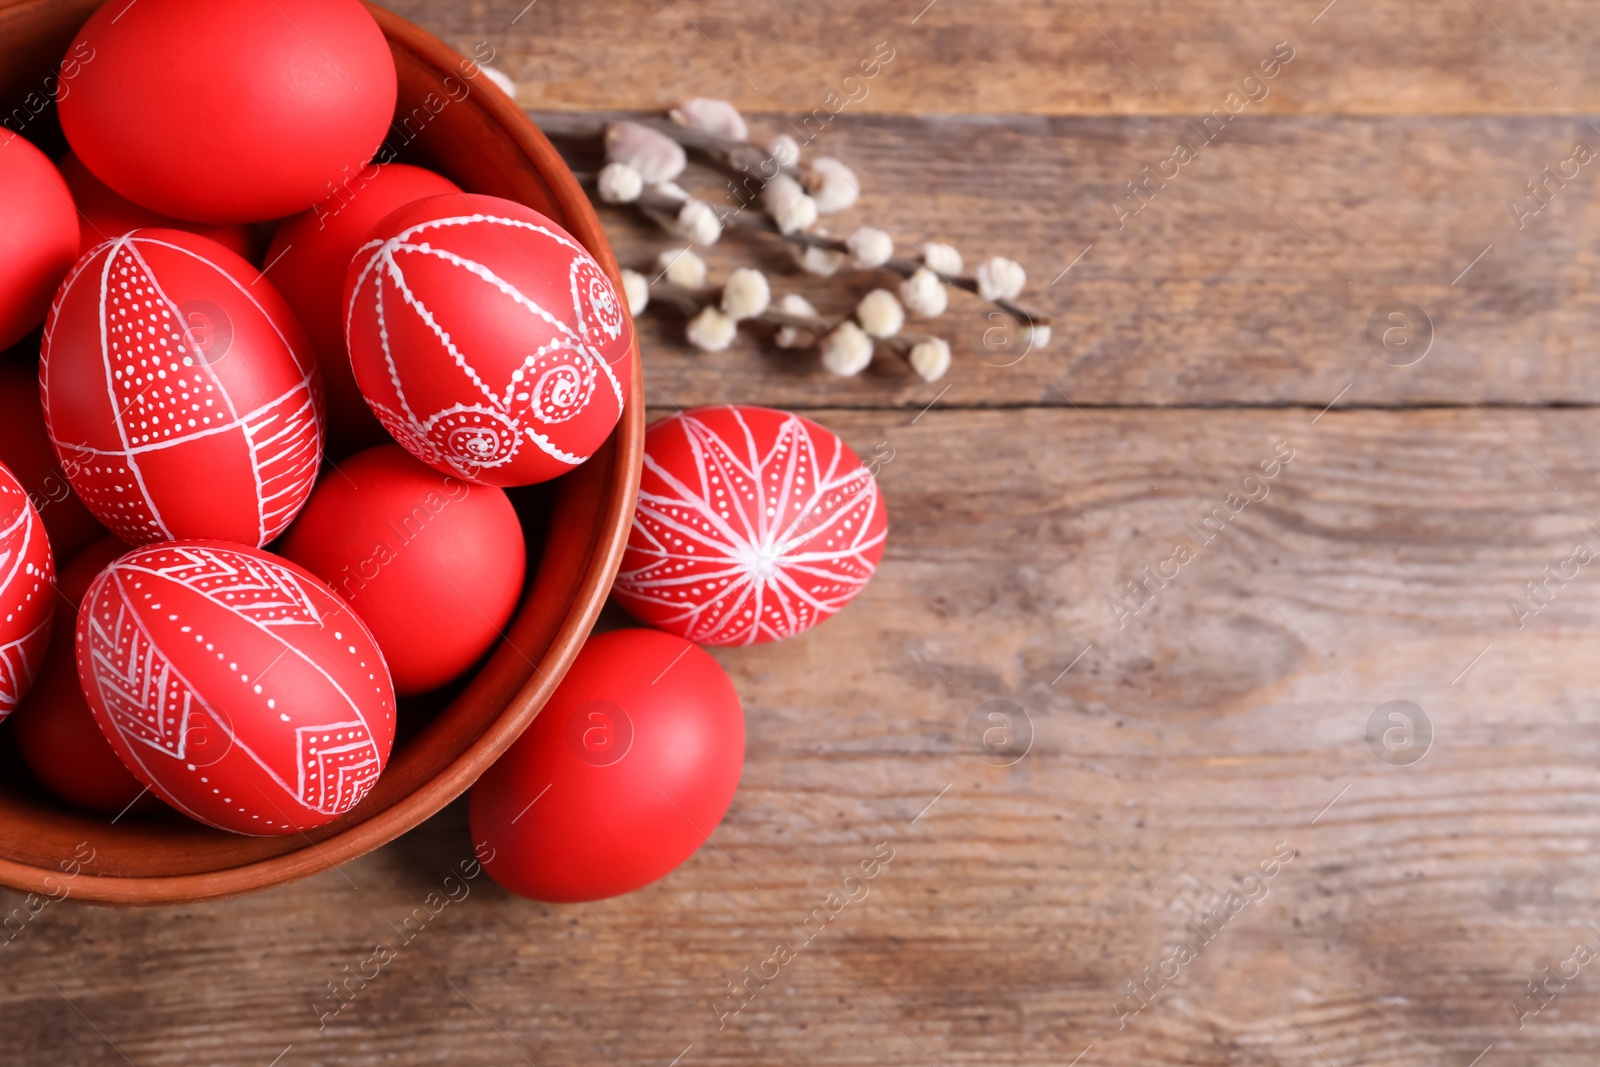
9,0 -> 1600,1067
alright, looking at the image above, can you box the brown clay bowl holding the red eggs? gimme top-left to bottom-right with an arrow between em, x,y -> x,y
0,0 -> 645,904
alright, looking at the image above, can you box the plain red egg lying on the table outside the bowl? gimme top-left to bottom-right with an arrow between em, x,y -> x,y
469,630 -> 744,902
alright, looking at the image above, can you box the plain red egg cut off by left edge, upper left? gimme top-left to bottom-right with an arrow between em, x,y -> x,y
0,130 -> 78,349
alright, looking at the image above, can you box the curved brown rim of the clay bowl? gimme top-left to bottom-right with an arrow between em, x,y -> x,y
0,0 -> 645,905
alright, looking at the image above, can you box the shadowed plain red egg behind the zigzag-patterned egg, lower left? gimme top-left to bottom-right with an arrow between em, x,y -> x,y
11,537 -> 162,814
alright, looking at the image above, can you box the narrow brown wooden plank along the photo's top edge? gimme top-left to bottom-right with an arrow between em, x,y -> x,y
377,0 -> 1600,115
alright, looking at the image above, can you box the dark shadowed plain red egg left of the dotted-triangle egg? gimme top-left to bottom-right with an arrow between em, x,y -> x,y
0,363 -> 106,560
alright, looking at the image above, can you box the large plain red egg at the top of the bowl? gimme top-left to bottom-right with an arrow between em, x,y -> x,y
61,0 -> 395,222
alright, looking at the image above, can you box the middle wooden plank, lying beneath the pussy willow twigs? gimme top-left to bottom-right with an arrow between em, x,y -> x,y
560,117 -> 1600,410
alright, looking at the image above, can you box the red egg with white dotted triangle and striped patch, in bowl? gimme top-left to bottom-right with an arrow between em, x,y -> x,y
38,230 -> 322,545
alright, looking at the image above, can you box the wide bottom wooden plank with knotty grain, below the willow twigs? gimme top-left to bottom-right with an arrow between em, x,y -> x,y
0,410 -> 1600,1067
